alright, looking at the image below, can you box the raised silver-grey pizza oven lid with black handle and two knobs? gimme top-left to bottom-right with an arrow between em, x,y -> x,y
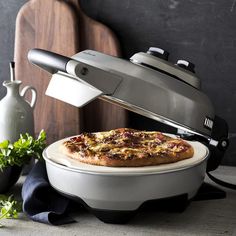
28,49 -> 228,169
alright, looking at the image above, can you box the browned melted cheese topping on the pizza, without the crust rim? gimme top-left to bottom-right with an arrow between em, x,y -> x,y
66,129 -> 190,160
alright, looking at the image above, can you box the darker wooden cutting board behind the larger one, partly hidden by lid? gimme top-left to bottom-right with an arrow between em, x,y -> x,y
67,0 -> 128,132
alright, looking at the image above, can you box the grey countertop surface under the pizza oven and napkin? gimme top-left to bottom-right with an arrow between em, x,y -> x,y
0,166 -> 236,236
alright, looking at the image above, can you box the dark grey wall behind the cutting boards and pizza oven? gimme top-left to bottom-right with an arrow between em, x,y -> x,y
0,0 -> 236,165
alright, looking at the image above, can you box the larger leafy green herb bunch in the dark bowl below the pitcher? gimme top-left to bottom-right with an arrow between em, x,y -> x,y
0,130 -> 46,170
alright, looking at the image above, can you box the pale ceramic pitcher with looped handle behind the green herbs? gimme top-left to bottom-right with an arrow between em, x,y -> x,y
0,80 -> 37,142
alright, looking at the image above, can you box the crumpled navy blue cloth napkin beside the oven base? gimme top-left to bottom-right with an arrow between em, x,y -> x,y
22,161 -> 75,225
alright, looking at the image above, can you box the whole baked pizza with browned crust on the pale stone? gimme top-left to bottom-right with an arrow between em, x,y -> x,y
60,128 -> 194,167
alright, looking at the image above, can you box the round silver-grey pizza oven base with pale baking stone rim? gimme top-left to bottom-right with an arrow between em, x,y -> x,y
43,137 -> 209,211
